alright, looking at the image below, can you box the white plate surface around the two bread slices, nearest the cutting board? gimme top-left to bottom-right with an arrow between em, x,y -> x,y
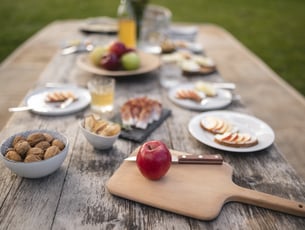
188,111 -> 274,152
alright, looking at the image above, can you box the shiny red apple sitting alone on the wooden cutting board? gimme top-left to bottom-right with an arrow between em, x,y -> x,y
137,141 -> 172,180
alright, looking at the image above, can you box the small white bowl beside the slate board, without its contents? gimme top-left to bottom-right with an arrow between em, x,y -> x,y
79,120 -> 120,150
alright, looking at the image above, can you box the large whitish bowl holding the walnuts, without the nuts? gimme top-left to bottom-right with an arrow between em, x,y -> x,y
0,129 -> 69,178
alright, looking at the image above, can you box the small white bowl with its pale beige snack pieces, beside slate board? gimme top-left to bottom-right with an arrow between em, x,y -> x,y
80,115 -> 121,150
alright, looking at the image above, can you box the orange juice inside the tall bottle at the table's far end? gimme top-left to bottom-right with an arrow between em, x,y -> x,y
119,18 -> 137,48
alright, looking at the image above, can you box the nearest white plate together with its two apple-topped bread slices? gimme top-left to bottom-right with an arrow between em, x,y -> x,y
188,110 -> 275,152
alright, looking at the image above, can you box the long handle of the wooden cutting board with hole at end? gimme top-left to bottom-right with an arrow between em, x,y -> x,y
227,185 -> 305,217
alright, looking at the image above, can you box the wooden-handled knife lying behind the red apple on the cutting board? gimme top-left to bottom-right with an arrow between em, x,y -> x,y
125,154 -> 223,165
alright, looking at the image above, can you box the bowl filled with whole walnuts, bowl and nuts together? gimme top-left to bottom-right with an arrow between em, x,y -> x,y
0,130 -> 69,178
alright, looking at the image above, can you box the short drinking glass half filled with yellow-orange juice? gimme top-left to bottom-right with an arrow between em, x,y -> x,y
88,76 -> 115,114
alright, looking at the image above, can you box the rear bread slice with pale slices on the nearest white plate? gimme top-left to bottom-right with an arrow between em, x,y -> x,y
200,116 -> 238,134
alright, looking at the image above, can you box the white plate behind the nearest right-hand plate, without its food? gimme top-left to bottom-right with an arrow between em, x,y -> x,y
168,83 -> 232,111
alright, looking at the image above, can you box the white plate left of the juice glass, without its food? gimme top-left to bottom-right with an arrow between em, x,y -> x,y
25,85 -> 91,116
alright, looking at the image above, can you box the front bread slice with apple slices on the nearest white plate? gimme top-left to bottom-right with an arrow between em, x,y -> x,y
214,132 -> 258,148
